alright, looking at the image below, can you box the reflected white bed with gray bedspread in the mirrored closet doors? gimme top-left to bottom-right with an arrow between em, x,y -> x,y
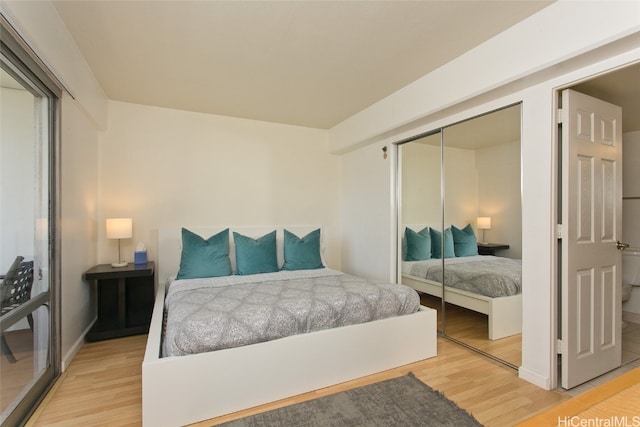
401,225 -> 522,340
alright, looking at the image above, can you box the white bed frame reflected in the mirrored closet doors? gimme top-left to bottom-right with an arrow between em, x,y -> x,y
402,274 -> 522,340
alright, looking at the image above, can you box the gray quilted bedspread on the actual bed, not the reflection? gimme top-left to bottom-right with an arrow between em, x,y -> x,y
163,269 -> 420,356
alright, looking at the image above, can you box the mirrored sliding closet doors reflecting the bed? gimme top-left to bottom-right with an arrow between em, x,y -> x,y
398,105 -> 522,367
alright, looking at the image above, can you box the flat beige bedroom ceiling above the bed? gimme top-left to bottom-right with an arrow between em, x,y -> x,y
53,0 -> 552,129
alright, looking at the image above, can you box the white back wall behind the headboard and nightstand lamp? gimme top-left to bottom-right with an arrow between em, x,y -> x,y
98,101 -> 340,274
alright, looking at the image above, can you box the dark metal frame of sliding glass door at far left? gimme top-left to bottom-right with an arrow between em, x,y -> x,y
0,15 -> 62,426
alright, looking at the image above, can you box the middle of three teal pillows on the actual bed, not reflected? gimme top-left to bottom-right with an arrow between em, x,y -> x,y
233,230 -> 278,275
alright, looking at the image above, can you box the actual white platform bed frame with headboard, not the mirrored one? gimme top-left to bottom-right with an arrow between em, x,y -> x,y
142,226 -> 437,427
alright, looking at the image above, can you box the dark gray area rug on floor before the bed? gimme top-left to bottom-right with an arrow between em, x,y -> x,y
222,373 -> 482,427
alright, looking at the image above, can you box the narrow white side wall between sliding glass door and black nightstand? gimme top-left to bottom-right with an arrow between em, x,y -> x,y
60,95 -> 99,369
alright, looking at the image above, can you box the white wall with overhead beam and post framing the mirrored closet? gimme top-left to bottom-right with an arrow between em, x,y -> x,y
330,1 -> 640,388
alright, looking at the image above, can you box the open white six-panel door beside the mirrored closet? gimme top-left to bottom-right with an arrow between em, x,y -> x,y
560,90 -> 622,389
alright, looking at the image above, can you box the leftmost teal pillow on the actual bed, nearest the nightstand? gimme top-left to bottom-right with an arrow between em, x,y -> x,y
176,228 -> 231,279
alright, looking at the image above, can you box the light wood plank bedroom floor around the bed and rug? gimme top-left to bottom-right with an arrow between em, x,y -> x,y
27,335 -> 569,427
